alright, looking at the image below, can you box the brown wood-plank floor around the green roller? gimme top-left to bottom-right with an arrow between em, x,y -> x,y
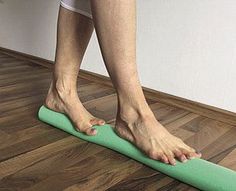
0,52 -> 236,191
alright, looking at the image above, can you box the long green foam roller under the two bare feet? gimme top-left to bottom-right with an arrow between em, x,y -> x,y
38,105 -> 236,191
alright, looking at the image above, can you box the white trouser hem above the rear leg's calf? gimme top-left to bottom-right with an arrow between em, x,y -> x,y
60,0 -> 92,19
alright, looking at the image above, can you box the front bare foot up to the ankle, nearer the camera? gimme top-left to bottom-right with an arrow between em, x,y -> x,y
115,104 -> 201,165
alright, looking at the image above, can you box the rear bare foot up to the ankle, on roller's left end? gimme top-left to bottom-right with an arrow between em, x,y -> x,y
45,83 -> 105,135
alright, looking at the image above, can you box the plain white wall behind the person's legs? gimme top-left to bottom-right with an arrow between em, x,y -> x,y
0,0 -> 236,112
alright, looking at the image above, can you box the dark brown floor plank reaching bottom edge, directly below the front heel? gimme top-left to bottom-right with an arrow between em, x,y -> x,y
23,150 -> 141,190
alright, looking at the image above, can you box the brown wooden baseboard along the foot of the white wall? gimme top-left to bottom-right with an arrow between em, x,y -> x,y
0,47 -> 236,126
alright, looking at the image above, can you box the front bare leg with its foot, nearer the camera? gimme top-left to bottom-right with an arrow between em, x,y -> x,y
90,0 -> 200,165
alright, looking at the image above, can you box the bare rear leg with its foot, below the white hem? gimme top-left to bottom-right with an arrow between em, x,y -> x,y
45,7 -> 104,135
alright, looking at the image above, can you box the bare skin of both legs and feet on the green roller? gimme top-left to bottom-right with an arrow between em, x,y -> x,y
45,0 -> 201,165
